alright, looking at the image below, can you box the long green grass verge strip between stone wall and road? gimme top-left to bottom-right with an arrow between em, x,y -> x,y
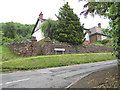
0,53 -> 116,72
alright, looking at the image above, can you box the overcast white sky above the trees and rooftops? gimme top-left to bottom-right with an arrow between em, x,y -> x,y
0,0 -> 108,28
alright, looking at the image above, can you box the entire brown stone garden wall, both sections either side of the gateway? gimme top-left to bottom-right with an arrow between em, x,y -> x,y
8,37 -> 113,57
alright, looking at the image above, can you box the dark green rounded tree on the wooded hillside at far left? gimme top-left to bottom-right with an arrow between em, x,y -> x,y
3,22 -> 17,38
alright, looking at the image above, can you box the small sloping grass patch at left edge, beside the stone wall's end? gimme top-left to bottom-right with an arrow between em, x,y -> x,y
0,46 -> 20,61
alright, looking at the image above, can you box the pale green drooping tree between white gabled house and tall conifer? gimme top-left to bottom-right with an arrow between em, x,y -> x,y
41,19 -> 58,40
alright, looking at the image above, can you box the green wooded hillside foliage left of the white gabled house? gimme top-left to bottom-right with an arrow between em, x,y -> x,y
0,22 -> 34,45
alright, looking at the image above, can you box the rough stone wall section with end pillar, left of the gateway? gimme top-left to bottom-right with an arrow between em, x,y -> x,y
8,37 -> 37,57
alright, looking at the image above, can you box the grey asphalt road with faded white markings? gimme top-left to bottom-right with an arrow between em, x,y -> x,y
0,60 -> 117,88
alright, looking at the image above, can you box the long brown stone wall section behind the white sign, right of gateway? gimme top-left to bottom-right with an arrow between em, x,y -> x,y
41,39 -> 113,55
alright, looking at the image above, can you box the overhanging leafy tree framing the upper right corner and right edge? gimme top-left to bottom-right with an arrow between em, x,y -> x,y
81,2 -> 120,59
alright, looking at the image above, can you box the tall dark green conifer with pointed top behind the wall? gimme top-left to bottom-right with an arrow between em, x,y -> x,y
55,2 -> 85,46
